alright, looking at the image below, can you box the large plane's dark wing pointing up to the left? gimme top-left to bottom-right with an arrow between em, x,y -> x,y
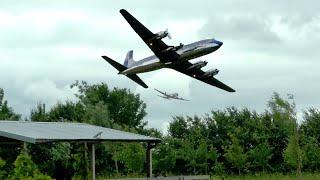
120,9 -> 179,63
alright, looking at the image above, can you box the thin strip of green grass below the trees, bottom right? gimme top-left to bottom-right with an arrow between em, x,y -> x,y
211,173 -> 320,180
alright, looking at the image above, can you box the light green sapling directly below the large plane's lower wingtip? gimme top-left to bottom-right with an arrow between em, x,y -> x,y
224,135 -> 247,175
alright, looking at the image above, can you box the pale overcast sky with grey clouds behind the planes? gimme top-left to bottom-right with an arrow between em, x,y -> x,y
0,0 -> 320,133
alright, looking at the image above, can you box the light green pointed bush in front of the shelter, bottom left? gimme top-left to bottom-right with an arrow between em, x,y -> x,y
10,151 -> 51,180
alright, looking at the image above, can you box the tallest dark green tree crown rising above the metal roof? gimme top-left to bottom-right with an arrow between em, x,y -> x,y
71,81 -> 147,129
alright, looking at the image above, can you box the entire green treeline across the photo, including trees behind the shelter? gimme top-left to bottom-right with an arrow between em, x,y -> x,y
0,82 -> 320,179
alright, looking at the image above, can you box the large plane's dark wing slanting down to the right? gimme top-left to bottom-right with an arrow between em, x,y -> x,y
170,61 -> 235,92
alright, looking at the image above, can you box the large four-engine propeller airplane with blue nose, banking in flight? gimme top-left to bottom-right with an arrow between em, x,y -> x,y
102,9 -> 235,92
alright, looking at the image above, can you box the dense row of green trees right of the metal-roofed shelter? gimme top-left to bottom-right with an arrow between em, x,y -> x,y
154,93 -> 320,176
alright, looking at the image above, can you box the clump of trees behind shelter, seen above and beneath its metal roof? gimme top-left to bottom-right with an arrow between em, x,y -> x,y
30,82 -> 150,178
